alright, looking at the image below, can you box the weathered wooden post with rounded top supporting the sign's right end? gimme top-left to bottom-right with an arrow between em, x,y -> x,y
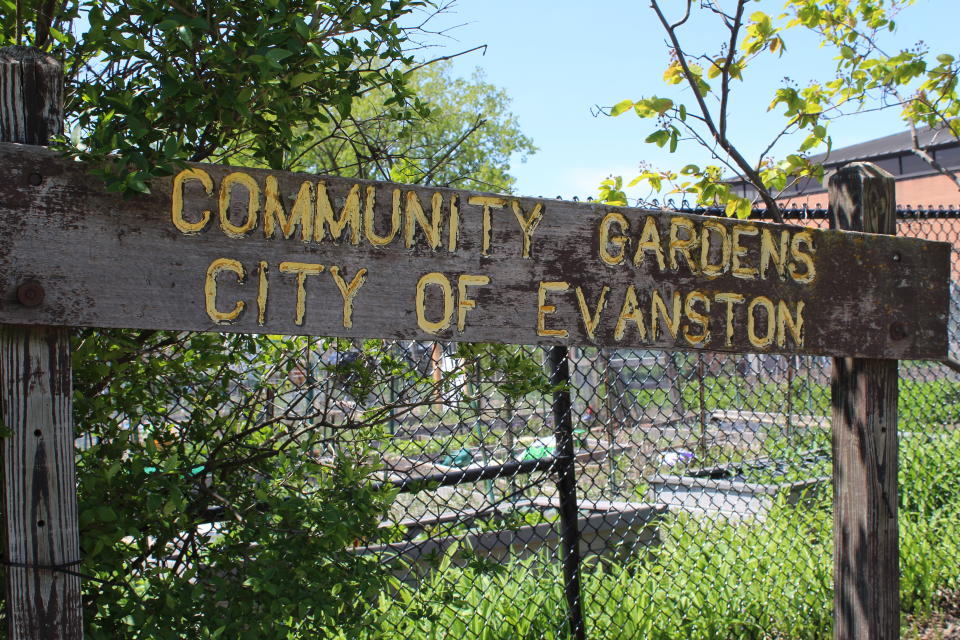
829,163 -> 906,640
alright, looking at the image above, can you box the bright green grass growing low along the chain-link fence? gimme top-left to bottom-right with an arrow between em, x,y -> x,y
341,432 -> 960,640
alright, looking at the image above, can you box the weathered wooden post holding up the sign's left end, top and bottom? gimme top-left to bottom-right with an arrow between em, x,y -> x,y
0,47 -> 83,640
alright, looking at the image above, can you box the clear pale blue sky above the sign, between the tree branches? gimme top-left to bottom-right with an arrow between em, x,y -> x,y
412,0 -> 960,198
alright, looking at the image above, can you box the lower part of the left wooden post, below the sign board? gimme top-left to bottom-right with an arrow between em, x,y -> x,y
0,326 -> 82,640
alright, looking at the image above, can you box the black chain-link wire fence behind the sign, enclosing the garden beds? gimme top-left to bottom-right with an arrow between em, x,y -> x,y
71,210 -> 960,640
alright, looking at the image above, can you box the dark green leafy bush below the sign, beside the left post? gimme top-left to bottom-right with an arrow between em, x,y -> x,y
74,331 -> 415,640
